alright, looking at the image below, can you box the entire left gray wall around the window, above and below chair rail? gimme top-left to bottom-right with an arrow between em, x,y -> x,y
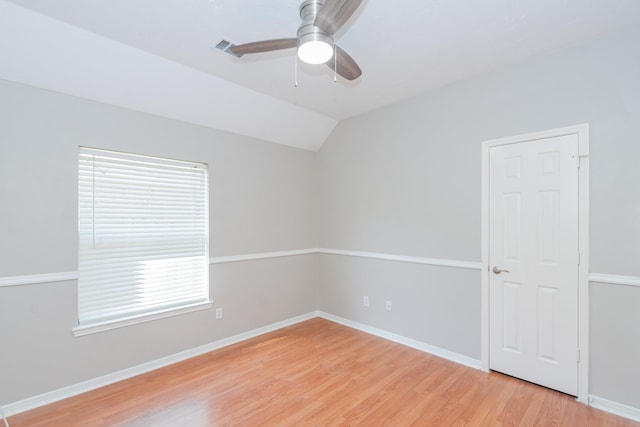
0,81 -> 317,405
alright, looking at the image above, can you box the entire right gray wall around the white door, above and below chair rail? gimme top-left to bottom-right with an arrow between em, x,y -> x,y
318,27 -> 640,408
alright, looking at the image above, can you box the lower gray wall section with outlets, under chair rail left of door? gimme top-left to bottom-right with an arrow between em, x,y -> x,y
319,255 -> 480,359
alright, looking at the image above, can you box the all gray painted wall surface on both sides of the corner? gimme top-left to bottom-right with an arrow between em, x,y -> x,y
0,22 -> 640,408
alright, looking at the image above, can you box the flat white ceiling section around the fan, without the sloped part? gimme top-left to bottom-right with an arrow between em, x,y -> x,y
0,0 -> 640,149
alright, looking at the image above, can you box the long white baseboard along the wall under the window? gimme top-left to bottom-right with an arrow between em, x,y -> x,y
0,311 -> 318,417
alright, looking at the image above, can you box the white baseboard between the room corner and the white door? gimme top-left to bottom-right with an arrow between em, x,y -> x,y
318,311 -> 482,369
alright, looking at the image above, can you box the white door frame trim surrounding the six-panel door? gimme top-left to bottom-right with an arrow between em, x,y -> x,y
480,124 -> 589,404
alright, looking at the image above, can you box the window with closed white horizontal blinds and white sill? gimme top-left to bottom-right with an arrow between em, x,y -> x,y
74,147 -> 211,335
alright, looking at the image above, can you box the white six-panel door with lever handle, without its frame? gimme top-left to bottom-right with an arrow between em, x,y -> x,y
489,134 -> 579,396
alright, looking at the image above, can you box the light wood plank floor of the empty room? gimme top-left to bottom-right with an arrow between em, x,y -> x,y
7,319 -> 640,427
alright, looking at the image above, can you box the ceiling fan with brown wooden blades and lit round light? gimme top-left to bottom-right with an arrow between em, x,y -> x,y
224,0 -> 362,80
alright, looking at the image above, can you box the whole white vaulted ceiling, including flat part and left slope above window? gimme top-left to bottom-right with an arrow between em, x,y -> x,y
0,0 -> 640,150
